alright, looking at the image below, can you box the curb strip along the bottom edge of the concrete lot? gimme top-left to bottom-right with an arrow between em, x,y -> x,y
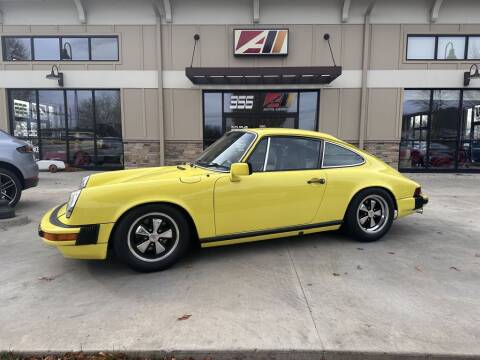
4,350 -> 480,360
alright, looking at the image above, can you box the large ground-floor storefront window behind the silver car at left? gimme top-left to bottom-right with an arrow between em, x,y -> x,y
9,90 -> 123,169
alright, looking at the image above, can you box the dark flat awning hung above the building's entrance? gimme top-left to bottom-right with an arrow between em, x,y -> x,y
185,66 -> 342,85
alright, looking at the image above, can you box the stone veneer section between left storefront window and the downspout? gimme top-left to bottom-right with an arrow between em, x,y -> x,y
123,140 -> 160,169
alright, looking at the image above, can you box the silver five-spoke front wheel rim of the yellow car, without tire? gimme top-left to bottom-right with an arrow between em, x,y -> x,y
128,213 -> 180,262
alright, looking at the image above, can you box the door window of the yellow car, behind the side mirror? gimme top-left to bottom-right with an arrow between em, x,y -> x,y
249,136 -> 321,172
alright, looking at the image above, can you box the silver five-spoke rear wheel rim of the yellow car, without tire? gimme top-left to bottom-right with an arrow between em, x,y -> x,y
357,195 -> 389,234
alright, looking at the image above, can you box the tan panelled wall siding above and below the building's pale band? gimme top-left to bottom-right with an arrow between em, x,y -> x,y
0,24 -> 480,149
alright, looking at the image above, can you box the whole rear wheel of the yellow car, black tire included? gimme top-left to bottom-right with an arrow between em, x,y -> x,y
344,188 -> 395,242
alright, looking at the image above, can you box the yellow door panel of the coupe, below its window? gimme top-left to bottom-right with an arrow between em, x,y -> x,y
214,169 -> 326,236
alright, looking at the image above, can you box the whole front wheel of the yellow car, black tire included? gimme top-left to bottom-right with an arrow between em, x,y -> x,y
113,204 -> 191,272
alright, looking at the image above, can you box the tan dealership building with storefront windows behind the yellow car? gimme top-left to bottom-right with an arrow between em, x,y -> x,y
0,0 -> 480,172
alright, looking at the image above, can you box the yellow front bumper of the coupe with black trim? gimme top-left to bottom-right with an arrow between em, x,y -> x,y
38,205 -> 114,259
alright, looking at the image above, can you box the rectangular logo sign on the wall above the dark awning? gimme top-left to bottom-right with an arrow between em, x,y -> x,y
234,29 -> 288,55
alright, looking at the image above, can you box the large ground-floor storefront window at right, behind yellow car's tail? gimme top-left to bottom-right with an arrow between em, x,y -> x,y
399,89 -> 480,170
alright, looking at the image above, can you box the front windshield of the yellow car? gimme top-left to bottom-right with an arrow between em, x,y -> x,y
194,131 -> 255,170
